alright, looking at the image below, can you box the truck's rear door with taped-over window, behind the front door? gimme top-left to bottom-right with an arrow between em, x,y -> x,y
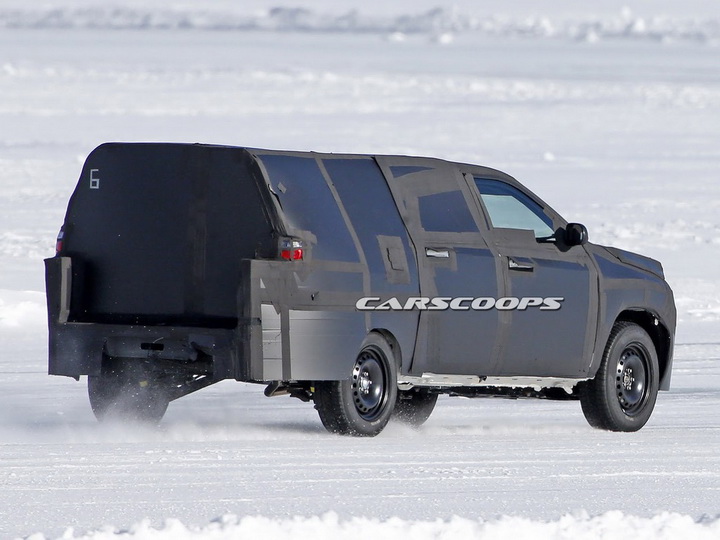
377,157 -> 502,375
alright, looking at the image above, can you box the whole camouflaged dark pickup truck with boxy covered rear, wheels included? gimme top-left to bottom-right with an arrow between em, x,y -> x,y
45,143 -> 676,436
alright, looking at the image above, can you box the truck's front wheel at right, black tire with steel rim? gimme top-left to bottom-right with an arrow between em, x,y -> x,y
580,321 -> 660,431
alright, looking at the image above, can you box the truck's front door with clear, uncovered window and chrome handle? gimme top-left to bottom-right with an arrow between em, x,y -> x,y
465,174 -> 598,378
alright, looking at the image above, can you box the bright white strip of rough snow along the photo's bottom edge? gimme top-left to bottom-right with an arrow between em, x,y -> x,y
28,511 -> 720,540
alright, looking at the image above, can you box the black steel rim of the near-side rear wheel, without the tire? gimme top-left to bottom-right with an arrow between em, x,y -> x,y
352,349 -> 387,421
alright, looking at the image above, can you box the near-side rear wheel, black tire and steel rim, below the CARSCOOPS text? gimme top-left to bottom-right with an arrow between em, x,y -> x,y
313,333 -> 398,437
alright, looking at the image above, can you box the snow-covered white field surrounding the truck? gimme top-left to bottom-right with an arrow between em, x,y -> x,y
0,0 -> 720,540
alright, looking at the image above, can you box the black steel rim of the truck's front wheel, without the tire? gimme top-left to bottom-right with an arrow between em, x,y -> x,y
615,343 -> 650,416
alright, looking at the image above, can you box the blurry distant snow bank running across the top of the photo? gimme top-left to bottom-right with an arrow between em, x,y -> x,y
0,7 -> 720,44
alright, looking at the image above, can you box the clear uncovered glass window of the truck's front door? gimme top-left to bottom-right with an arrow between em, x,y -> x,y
475,178 -> 555,238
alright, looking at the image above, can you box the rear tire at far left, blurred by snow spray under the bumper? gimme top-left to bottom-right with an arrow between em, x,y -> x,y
88,358 -> 170,424
